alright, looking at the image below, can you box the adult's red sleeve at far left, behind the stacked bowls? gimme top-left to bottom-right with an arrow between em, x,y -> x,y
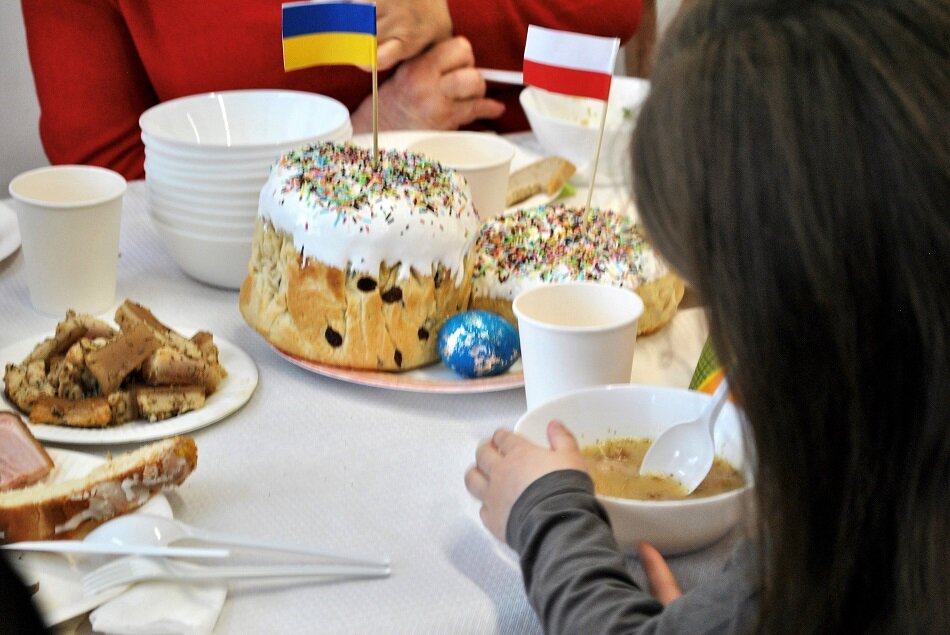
22,0 -> 158,179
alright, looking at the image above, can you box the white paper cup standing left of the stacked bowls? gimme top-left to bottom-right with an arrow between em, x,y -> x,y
10,165 -> 126,317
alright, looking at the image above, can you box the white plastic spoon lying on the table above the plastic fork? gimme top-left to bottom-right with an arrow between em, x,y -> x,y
86,514 -> 389,568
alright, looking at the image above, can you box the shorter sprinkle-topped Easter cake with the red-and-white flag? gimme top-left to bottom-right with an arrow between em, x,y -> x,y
471,205 -> 684,335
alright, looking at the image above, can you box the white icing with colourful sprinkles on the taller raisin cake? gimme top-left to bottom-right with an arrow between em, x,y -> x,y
259,143 -> 480,283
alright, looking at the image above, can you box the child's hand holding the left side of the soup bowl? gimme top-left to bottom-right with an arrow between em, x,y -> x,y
465,421 -> 587,541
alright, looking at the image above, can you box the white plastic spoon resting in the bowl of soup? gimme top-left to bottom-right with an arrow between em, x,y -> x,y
640,378 -> 729,494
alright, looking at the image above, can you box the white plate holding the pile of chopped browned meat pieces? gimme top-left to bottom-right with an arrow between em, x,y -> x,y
0,329 -> 257,445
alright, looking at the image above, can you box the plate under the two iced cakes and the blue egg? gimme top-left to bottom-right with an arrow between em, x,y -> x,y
274,308 -> 708,394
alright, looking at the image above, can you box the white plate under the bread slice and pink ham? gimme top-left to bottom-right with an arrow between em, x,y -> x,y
8,448 -> 172,626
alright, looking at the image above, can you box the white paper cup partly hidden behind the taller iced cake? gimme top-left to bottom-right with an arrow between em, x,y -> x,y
409,132 -> 515,220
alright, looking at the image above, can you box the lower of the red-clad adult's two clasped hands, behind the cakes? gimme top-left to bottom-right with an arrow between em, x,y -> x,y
353,37 -> 505,132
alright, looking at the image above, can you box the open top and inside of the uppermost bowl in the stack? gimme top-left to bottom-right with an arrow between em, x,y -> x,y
139,90 -> 350,151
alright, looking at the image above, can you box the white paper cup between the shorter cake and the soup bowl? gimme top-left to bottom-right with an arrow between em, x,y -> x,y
512,282 -> 643,409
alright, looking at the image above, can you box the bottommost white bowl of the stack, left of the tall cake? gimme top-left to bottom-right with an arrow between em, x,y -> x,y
152,217 -> 251,289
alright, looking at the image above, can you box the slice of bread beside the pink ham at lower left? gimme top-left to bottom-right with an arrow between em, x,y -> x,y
0,437 -> 198,543
